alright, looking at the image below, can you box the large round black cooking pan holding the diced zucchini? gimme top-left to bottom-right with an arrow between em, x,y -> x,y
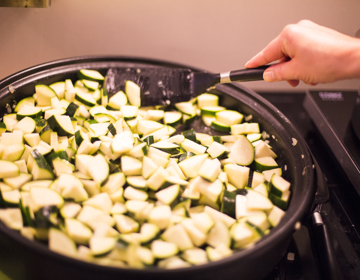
0,56 -> 315,280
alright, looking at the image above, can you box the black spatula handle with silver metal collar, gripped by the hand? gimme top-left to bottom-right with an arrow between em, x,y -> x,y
220,65 -> 271,83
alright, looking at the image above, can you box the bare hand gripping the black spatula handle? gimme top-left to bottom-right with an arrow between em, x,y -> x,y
245,20 -> 360,86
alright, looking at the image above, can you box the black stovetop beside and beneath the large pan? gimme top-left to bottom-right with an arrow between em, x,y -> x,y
260,91 -> 360,280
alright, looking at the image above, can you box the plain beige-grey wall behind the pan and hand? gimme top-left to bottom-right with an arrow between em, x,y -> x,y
0,0 -> 360,91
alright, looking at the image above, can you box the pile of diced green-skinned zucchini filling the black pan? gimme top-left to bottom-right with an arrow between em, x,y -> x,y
0,69 -> 291,268
